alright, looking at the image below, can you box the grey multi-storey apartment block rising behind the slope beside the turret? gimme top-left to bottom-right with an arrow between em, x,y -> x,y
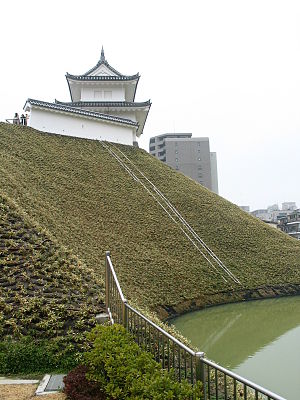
149,133 -> 218,193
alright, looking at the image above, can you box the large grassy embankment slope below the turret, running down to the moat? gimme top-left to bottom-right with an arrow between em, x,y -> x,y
0,123 -> 300,318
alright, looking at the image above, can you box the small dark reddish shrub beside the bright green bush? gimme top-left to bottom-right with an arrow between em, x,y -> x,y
64,365 -> 107,400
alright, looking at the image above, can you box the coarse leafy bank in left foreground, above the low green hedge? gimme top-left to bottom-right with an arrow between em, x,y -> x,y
0,193 -> 103,339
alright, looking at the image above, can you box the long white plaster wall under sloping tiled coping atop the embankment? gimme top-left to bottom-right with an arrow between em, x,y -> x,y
28,107 -> 136,146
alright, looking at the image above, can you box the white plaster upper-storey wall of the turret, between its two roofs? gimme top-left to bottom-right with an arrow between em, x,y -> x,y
81,85 -> 125,101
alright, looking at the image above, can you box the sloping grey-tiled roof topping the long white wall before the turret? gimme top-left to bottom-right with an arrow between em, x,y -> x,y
24,99 -> 139,128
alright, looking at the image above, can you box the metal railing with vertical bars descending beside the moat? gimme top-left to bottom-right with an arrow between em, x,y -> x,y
105,252 -> 285,400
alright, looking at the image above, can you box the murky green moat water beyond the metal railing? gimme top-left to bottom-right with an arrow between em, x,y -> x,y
171,296 -> 300,400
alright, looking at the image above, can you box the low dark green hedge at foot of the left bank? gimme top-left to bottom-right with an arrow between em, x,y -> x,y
0,337 -> 82,374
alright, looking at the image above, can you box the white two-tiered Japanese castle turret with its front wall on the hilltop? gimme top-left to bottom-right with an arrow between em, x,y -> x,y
24,48 -> 151,145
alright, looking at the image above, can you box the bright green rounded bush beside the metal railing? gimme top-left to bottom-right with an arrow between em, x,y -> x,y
85,325 -> 201,400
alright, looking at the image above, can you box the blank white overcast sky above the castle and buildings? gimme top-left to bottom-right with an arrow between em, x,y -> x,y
0,0 -> 300,210
